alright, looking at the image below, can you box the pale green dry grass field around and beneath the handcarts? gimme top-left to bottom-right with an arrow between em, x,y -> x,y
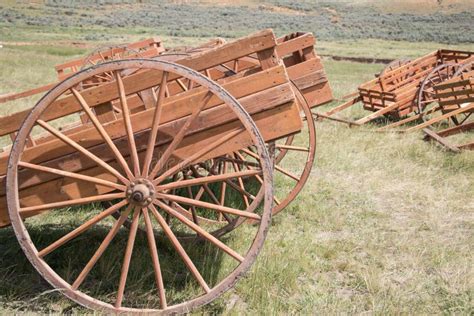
0,1 -> 474,315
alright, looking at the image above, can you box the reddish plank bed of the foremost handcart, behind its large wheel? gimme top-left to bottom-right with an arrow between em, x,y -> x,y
0,30 -> 301,226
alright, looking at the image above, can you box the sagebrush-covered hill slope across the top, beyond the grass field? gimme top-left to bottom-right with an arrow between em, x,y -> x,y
0,0 -> 474,43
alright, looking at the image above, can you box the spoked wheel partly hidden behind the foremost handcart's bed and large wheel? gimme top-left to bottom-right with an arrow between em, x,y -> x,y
171,81 -> 316,230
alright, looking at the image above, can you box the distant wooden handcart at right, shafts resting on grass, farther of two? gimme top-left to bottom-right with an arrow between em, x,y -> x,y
319,49 -> 474,129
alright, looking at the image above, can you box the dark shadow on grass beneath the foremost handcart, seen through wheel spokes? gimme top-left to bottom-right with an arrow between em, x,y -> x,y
0,224 -> 233,312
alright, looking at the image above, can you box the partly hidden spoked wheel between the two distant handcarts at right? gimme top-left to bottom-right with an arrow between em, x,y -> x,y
416,64 -> 466,125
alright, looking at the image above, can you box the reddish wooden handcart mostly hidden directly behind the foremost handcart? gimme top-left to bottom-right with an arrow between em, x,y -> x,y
47,32 -> 332,217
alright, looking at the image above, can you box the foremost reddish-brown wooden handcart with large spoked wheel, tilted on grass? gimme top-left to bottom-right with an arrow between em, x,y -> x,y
0,30 -> 330,314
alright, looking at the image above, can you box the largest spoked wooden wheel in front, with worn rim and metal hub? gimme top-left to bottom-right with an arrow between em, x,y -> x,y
7,60 -> 273,313
